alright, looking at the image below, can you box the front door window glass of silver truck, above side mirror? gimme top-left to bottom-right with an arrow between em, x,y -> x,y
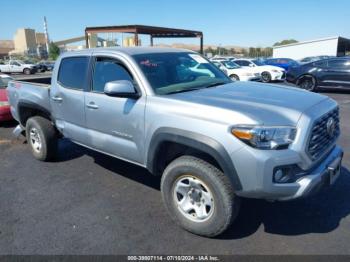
92,57 -> 133,93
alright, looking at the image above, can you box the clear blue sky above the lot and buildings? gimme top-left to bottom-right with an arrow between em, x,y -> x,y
0,0 -> 350,47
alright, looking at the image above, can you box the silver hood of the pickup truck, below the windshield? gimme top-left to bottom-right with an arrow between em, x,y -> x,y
169,82 -> 329,126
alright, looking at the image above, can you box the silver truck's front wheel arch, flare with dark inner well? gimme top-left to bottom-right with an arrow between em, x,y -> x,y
146,128 -> 242,191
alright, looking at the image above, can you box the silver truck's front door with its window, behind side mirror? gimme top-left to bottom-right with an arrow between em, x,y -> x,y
85,55 -> 146,163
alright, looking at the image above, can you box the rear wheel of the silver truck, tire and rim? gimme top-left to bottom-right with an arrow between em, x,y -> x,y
26,116 -> 58,161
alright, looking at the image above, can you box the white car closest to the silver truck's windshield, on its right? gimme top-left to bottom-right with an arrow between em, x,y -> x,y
213,61 -> 260,81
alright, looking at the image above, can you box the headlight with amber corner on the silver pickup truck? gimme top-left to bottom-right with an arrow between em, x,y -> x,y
231,125 -> 296,149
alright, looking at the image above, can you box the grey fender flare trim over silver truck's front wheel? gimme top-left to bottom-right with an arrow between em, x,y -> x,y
146,128 -> 242,191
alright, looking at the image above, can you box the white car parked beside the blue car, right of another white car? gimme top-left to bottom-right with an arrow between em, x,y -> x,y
234,59 -> 286,83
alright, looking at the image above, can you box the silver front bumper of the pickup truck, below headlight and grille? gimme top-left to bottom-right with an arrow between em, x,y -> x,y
232,146 -> 343,201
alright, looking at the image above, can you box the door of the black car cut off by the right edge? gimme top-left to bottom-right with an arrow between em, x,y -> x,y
324,58 -> 350,87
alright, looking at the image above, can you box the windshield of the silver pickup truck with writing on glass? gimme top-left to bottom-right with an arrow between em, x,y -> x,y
133,52 -> 231,95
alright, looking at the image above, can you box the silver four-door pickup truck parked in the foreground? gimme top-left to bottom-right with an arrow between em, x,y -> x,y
8,47 -> 343,237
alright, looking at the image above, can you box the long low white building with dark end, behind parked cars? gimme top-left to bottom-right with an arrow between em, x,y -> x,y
273,36 -> 350,60
